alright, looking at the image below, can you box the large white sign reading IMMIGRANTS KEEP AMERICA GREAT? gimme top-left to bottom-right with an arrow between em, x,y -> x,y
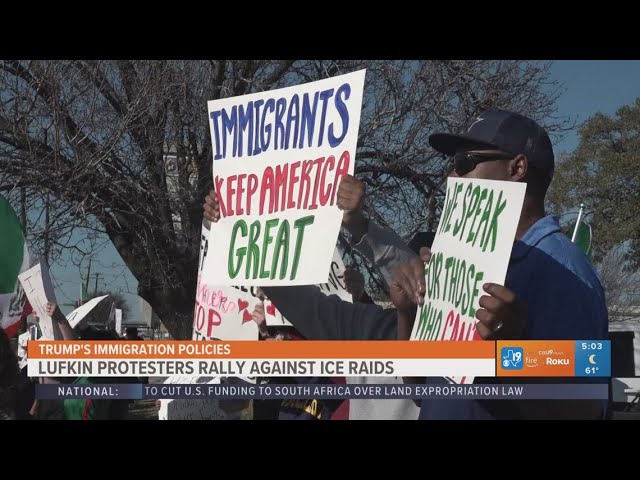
203,70 -> 365,286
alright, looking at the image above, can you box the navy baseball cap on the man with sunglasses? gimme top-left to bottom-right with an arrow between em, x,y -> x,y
429,110 -> 555,179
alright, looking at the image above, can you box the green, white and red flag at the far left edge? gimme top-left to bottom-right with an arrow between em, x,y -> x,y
0,195 -> 29,337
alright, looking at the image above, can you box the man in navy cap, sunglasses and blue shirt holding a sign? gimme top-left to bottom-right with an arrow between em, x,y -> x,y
391,110 -> 608,419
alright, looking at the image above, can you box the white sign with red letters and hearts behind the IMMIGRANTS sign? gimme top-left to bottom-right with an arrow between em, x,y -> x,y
192,225 -> 260,340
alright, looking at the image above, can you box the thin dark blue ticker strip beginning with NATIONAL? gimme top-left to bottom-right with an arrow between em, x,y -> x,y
36,383 -> 609,400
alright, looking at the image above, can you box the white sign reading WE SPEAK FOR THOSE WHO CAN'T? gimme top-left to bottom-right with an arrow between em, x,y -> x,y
411,178 -> 526,383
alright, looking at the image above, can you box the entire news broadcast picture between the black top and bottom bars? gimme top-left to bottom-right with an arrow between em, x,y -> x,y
0,60 -> 640,421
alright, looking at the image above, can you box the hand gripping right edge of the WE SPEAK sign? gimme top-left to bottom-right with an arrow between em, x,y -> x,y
476,283 -> 527,340
